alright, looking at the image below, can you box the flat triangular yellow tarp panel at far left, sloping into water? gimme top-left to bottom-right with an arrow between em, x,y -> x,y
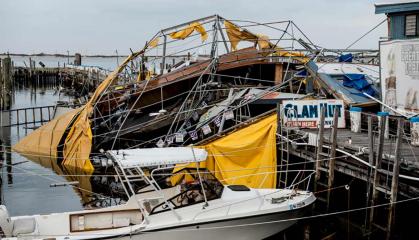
12,108 -> 81,157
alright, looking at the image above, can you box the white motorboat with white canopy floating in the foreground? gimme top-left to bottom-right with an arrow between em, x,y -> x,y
0,147 -> 315,240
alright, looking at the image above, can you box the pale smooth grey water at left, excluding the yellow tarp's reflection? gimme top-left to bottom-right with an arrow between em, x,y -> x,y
1,90 -> 83,215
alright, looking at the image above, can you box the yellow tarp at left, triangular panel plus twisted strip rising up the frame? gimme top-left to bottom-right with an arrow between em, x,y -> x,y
13,49 -> 145,172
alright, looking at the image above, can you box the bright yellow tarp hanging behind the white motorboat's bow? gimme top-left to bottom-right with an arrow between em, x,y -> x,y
172,114 -> 277,188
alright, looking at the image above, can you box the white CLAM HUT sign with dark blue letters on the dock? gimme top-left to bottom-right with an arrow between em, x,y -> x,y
282,100 -> 345,128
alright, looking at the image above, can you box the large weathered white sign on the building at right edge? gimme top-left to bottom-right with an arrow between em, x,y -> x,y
380,40 -> 419,113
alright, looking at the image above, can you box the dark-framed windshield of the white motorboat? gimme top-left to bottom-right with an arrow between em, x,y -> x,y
150,168 -> 224,215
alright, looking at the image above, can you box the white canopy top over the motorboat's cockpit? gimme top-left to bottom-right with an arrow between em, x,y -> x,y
108,147 -> 208,168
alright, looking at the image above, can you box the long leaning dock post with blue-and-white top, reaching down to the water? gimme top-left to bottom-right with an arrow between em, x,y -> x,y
369,112 -> 389,229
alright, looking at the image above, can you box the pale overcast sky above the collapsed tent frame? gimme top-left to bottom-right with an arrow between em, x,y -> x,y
0,0 -> 394,54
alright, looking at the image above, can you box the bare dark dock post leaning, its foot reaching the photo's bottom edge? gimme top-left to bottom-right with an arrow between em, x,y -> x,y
387,118 -> 404,240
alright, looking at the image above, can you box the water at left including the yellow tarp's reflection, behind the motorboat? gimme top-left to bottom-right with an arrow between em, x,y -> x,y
0,89 -> 124,215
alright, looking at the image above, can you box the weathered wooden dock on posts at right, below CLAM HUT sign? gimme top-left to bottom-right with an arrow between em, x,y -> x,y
279,112 -> 419,238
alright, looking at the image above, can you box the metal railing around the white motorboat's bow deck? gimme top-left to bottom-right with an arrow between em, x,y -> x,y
193,170 -> 316,220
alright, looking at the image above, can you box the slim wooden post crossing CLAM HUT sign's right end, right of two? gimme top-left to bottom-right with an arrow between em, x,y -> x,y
327,107 -> 339,211
